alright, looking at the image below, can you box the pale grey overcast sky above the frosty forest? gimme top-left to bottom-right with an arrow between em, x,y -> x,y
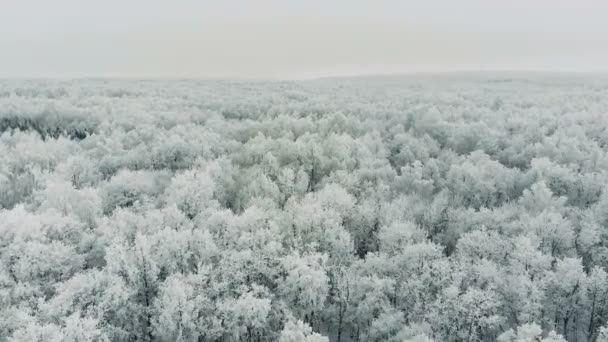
0,0 -> 608,78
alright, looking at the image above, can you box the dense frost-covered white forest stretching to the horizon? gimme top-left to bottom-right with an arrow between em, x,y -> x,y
0,75 -> 608,342
